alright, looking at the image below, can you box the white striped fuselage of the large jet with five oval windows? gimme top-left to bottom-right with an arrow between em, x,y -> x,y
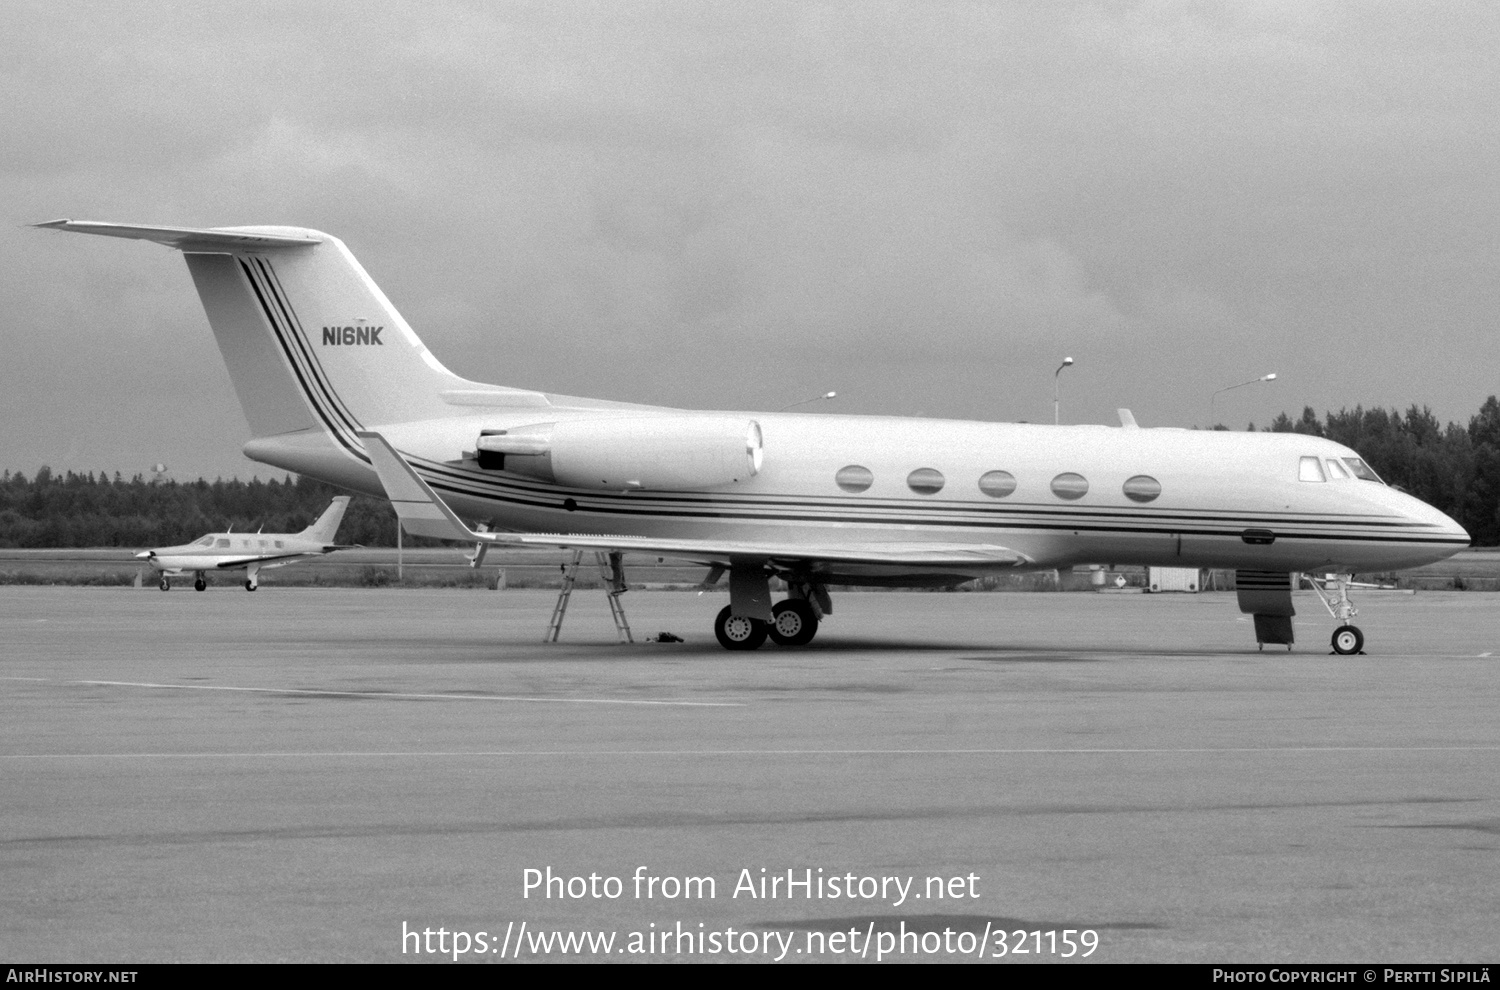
246,408 -> 1469,584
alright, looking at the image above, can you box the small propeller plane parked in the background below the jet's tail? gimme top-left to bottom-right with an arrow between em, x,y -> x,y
137,495 -> 350,591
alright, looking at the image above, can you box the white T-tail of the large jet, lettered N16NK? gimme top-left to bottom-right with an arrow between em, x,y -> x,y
38,221 -> 546,488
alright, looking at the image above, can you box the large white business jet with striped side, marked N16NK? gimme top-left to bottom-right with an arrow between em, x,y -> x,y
38,221 -> 1469,654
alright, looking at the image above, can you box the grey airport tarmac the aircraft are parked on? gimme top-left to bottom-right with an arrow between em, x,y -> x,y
0,587 -> 1500,965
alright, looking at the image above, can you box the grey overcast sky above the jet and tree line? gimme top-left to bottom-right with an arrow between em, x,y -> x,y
0,0 -> 1500,479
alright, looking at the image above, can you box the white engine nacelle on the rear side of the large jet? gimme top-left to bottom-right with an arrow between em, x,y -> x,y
477,416 -> 764,492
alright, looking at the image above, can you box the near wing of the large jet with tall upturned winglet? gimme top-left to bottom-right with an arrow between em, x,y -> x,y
359,432 -> 1032,567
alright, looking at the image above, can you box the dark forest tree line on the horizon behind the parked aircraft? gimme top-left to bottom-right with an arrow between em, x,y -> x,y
0,396 -> 1500,548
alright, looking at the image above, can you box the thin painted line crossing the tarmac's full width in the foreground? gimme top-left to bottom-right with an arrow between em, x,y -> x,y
0,746 -> 1500,761
